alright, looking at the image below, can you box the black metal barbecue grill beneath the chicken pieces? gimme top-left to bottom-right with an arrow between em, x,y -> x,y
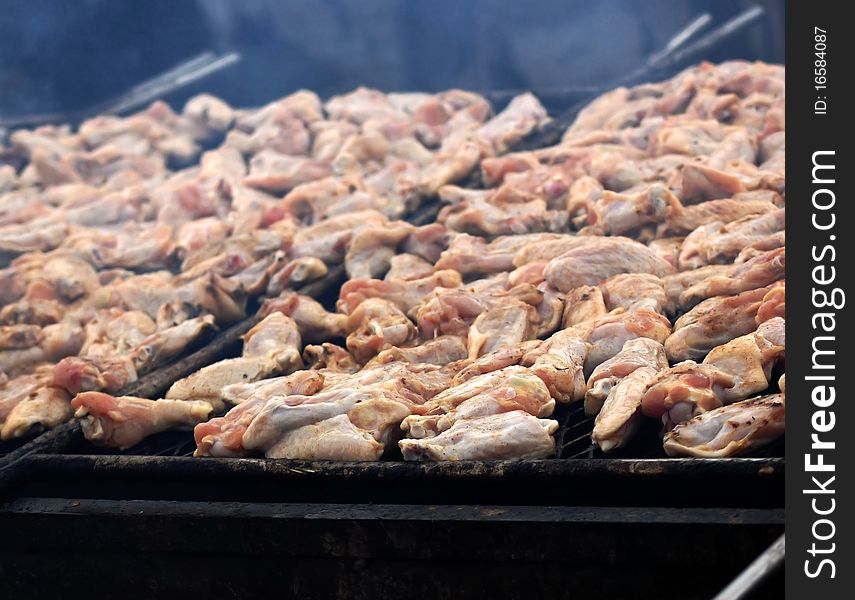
0,3 -> 785,599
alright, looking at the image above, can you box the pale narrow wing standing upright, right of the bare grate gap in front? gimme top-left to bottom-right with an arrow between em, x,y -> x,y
591,366 -> 659,452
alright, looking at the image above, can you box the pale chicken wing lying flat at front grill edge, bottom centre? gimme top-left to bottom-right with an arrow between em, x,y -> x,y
398,410 -> 558,461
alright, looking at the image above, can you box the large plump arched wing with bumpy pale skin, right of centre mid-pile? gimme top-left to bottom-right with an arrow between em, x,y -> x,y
544,237 -> 674,292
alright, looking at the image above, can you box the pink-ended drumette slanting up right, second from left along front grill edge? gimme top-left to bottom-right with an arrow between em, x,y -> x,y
193,370 -> 324,457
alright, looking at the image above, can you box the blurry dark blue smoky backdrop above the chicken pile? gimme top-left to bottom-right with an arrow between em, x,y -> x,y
0,0 -> 783,118
